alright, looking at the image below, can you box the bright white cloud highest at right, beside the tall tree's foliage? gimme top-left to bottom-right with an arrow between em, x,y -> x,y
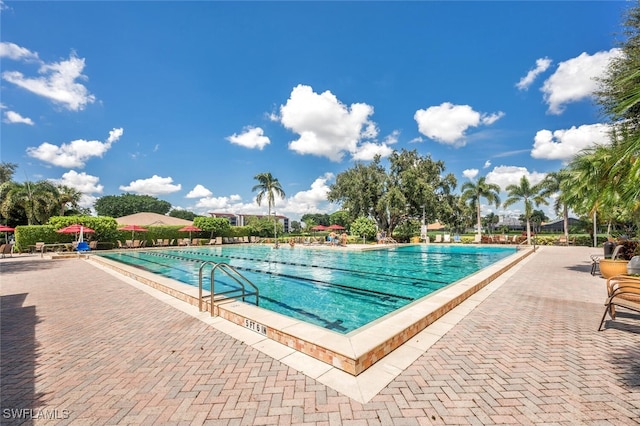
541,48 -> 622,114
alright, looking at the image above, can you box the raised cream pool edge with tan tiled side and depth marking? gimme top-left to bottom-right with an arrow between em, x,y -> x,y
90,243 -> 533,376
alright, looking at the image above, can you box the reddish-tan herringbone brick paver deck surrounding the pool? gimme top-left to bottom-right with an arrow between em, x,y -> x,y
0,247 -> 640,425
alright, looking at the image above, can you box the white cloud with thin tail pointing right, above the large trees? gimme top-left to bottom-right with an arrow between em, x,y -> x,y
413,102 -> 504,147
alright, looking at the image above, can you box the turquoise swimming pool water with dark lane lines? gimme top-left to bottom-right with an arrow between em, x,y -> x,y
101,245 -> 516,333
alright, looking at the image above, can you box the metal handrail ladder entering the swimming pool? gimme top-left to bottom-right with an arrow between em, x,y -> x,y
198,262 -> 260,316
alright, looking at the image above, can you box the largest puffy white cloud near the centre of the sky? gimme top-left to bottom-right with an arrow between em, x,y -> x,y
280,85 -> 378,161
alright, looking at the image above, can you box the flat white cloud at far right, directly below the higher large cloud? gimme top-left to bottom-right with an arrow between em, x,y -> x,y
531,123 -> 611,161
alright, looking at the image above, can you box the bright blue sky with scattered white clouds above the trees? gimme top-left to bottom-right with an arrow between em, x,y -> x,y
0,1 -> 632,223
